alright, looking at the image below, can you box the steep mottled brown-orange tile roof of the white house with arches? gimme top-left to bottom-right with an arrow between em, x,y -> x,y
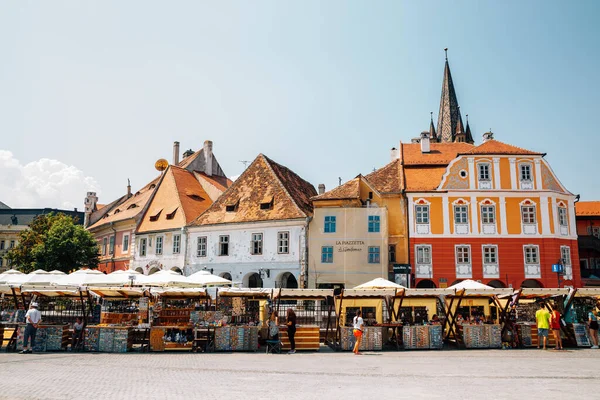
190,154 -> 317,226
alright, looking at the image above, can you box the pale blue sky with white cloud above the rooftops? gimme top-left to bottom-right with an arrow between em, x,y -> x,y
0,0 -> 600,209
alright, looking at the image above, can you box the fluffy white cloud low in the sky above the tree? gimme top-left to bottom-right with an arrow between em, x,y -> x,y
0,150 -> 100,210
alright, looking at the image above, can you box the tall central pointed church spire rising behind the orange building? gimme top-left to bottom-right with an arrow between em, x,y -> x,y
437,48 -> 462,143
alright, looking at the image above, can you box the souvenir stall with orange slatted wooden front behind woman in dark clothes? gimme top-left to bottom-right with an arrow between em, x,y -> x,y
273,288 -> 334,351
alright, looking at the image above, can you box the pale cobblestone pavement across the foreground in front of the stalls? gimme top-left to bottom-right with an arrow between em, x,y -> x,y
0,350 -> 600,400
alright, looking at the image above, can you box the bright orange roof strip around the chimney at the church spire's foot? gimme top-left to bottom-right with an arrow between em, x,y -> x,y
400,143 -> 474,165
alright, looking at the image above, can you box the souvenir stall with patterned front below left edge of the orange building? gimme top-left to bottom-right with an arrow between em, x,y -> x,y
396,289 -> 444,350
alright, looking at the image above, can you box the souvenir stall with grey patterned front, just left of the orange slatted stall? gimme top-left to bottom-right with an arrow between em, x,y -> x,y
211,288 -> 270,351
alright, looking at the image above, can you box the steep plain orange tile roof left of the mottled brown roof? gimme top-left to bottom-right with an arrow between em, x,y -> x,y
138,165 -> 218,233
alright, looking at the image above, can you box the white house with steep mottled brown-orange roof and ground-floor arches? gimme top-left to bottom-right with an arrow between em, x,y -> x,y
185,154 -> 316,288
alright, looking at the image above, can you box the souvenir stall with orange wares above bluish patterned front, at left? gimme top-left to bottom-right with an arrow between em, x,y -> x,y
84,286 -> 149,353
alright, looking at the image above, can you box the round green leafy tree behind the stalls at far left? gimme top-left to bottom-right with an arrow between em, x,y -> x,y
8,213 -> 98,273
